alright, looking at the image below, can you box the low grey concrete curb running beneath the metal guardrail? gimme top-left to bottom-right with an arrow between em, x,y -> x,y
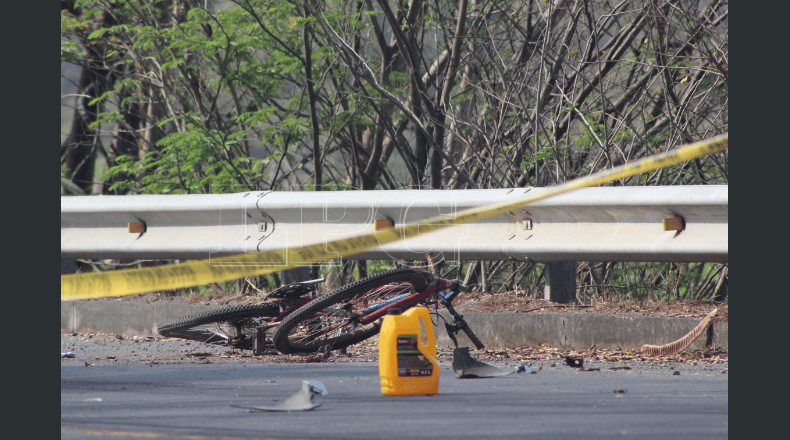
60,301 -> 728,350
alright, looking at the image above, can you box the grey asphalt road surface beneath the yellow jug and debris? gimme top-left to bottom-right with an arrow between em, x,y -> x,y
61,335 -> 729,439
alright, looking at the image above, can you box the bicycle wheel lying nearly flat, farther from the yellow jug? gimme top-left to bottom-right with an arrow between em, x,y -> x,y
157,303 -> 280,349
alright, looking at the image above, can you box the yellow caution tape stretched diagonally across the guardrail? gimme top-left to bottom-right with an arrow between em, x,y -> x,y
60,133 -> 728,300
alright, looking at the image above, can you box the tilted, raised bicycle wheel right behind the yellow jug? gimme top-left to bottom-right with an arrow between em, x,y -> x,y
272,269 -> 434,354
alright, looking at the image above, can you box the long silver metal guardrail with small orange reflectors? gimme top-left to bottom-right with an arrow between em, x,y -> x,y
60,185 -> 728,262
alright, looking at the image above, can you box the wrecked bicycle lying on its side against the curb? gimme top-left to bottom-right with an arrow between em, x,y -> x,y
159,268 -> 484,355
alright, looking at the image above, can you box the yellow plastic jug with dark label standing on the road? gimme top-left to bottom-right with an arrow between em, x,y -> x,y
379,307 -> 439,396
